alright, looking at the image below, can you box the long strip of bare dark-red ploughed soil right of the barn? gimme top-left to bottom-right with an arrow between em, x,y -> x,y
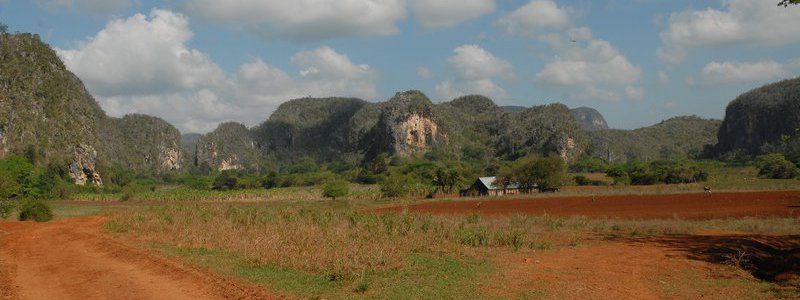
377,191 -> 800,219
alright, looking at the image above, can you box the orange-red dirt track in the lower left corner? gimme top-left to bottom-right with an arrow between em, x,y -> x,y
0,217 -> 277,299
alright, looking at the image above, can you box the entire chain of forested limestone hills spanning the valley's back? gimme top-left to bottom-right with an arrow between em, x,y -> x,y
0,30 -> 780,184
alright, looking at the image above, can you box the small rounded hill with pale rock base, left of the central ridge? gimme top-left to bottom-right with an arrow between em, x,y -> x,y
195,122 -> 261,171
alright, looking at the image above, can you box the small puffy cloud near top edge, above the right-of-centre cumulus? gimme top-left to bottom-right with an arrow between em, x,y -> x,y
499,0 -> 570,36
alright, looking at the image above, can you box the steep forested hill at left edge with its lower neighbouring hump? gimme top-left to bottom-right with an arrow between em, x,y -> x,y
0,33 -> 182,184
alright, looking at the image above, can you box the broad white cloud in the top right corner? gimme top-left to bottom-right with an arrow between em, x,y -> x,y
658,0 -> 800,64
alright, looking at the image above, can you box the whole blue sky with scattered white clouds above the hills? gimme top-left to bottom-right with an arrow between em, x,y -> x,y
0,0 -> 800,133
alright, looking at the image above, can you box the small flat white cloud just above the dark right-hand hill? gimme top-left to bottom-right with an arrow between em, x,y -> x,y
702,60 -> 788,85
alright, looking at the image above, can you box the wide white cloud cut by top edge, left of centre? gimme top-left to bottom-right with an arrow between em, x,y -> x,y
182,0 -> 406,41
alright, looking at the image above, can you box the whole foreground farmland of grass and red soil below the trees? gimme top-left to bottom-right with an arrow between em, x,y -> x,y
0,189 -> 800,299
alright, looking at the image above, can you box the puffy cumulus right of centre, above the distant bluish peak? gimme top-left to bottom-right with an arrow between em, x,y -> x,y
536,29 -> 644,101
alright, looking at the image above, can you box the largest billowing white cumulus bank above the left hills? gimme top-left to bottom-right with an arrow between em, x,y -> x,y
57,10 -> 378,132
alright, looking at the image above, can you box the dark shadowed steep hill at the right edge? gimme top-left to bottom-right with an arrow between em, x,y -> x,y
716,78 -> 800,155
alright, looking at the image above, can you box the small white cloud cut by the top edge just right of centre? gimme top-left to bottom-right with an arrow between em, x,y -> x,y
411,0 -> 496,28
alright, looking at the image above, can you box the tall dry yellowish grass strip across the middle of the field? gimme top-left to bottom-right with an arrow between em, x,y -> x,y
107,203 -> 800,279
